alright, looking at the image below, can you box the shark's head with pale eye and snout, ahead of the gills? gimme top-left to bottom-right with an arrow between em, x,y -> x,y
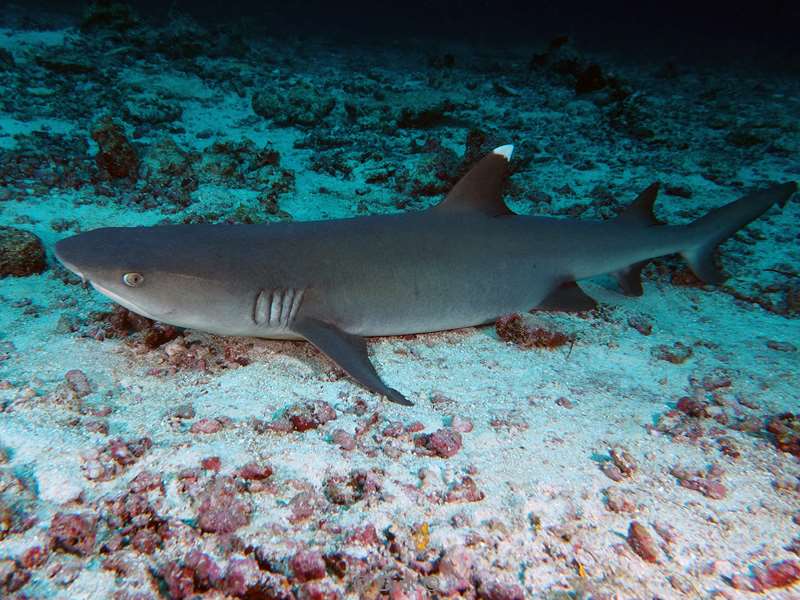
56,227 -> 241,330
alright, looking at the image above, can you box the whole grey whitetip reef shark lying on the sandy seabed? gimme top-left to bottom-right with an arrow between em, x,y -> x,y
56,145 -> 797,405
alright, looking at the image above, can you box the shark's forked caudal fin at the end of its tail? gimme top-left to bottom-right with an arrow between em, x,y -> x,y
681,182 -> 797,284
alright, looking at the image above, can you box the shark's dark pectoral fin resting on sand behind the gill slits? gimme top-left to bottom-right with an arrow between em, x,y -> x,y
292,317 -> 414,406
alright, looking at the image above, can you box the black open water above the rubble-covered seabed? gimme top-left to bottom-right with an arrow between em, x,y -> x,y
9,0 -> 800,63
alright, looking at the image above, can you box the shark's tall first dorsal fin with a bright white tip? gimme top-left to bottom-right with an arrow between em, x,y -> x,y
434,144 -> 514,217
